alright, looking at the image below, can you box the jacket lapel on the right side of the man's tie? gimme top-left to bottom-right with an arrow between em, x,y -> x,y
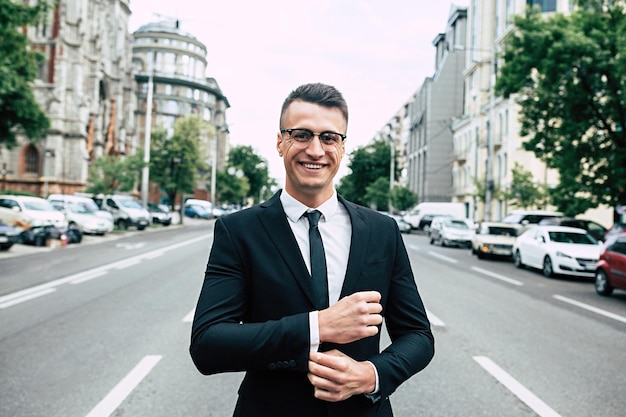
338,196 -> 370,298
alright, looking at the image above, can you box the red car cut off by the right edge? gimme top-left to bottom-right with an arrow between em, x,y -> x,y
595,233 -> 626,295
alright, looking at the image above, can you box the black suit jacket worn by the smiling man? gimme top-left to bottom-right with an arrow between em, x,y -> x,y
190,191 -> 434,417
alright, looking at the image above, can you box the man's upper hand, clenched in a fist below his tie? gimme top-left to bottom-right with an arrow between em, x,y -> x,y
318,291 -> 383,344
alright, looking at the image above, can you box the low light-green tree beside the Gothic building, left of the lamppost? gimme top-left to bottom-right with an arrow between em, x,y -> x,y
86,153 -> 143,194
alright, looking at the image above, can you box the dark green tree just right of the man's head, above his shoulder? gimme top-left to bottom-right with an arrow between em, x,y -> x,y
337,140 -> 390,208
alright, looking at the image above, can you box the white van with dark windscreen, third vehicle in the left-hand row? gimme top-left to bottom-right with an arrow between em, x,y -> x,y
93,194 -> 151,230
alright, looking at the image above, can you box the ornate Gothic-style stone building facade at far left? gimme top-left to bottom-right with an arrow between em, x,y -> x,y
0,0 -> 135,196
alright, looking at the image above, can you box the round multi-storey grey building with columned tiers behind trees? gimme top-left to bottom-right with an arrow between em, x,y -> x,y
132,20 -> 230,204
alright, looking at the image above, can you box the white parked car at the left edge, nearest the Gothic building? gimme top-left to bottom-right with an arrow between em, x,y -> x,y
0,195 -> 67,229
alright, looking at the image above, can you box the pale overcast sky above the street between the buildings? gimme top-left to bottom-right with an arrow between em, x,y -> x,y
130,0 -> 469,186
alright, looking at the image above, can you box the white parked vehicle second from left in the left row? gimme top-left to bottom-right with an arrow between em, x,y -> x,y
48,194 -> 113,235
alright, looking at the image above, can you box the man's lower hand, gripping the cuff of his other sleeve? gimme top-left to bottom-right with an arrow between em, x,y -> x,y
308,350 -> 376,402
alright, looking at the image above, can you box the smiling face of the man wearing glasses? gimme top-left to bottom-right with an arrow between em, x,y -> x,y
276,100 -> 347,207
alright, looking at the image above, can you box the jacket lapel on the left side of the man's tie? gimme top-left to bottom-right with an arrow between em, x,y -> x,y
259,191 -> 316,306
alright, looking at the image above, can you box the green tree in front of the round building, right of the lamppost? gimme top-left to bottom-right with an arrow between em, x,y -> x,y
150,115 -> 208,205
